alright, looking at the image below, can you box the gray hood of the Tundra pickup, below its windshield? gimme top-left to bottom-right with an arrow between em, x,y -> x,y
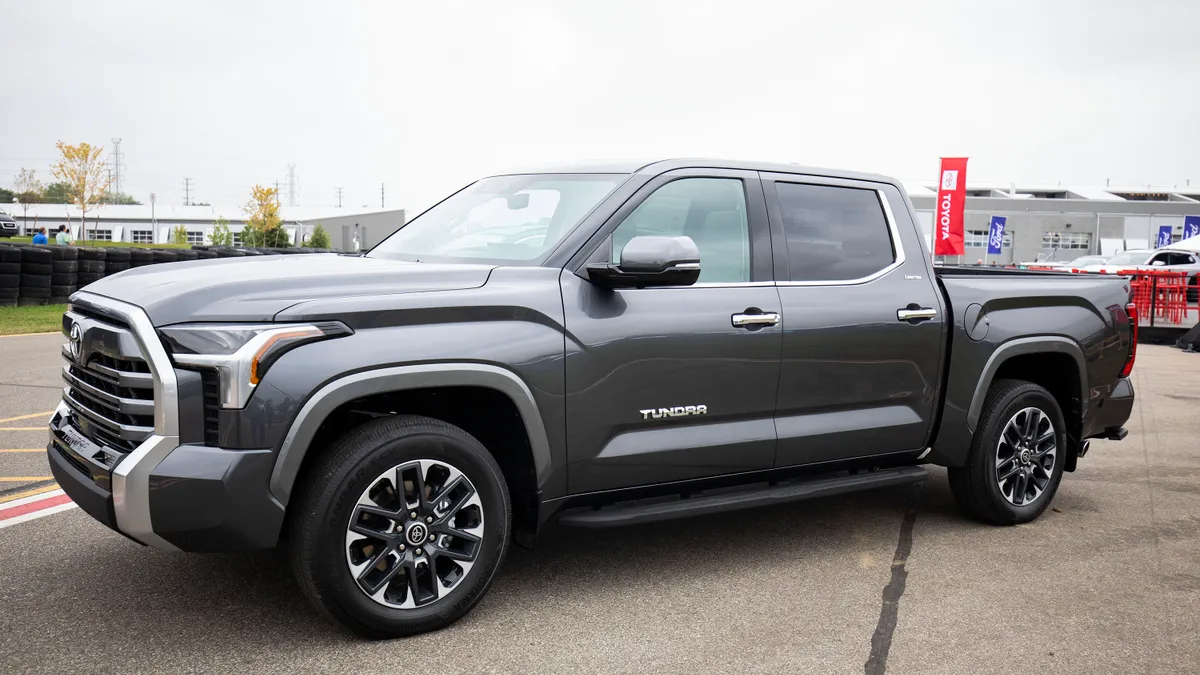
85,253 -> 492,325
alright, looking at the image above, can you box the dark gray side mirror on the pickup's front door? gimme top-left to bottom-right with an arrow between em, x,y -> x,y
588,237 -> 700,288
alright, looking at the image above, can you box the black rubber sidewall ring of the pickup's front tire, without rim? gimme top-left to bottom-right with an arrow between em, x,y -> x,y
313,422 -> 509,634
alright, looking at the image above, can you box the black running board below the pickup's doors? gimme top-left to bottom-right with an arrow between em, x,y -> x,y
558,466 -> 929,527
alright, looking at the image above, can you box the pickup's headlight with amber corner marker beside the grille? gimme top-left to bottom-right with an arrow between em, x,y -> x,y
158,322 -> 353,408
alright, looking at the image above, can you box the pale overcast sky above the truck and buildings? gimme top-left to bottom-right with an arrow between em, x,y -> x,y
0,0 -> 1200,209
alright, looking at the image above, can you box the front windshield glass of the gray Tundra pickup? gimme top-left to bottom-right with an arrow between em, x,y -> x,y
367,174 -> 625,262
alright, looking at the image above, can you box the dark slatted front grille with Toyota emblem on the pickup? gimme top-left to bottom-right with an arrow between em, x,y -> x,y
62,305 -> 155,453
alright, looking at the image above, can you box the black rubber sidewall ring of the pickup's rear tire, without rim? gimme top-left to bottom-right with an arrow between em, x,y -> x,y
977,384 -> 1067,522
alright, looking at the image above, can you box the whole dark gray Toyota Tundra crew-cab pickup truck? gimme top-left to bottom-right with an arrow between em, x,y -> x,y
48,160 -> 1136,638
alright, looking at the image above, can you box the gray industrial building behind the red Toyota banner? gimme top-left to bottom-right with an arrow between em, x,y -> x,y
905,181 -> 1200,264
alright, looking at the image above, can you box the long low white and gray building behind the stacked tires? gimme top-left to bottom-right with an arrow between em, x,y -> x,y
7,204 -> 404,251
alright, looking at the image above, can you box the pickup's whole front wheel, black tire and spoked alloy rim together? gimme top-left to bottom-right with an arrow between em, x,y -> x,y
290,417 -> 512,638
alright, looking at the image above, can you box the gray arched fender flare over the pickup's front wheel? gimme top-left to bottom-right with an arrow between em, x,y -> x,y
270,363 -> 552,506
